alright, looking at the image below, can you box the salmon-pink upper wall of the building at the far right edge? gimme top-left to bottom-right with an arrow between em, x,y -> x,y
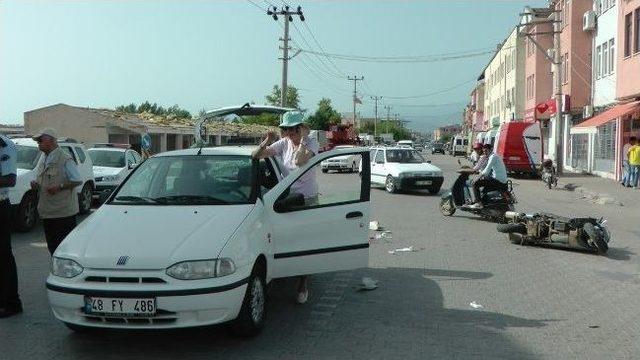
616,0 -> 640,99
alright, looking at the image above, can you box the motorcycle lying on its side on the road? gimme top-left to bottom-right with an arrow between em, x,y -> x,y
497,211 -> 610,254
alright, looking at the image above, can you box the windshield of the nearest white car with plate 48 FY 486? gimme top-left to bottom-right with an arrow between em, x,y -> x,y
110,155 -> 253,205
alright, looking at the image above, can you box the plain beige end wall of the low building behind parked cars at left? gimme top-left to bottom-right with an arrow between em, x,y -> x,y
24,104 -> 109,144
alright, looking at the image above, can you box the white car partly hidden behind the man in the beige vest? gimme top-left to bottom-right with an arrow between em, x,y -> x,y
9,138 -> 94,231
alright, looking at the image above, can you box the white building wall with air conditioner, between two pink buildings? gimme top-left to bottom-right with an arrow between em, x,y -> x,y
591,0 -> 618,106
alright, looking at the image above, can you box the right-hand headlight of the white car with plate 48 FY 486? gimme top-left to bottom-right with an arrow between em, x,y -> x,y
167,258 -> 236,280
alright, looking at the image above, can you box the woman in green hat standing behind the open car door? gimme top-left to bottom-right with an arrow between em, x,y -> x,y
251,111 -> 320,304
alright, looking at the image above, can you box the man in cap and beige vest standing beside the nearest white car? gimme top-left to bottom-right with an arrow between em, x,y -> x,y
31,128 -> 82,255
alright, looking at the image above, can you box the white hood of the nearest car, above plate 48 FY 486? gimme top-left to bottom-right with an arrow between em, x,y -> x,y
55,204 -> 255,269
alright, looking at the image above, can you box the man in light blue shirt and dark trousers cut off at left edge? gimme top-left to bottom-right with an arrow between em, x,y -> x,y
0,135 -> 22,318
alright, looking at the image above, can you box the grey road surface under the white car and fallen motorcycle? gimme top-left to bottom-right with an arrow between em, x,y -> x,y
0,155 -> 640,359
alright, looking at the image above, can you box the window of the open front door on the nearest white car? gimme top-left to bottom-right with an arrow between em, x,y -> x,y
278,153 -> 370,211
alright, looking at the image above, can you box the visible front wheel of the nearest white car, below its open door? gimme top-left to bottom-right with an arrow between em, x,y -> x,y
231,262 -> 267,337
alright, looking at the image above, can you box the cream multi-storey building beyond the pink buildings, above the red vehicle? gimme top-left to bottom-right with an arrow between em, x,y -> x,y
484,29 -> 525,128
